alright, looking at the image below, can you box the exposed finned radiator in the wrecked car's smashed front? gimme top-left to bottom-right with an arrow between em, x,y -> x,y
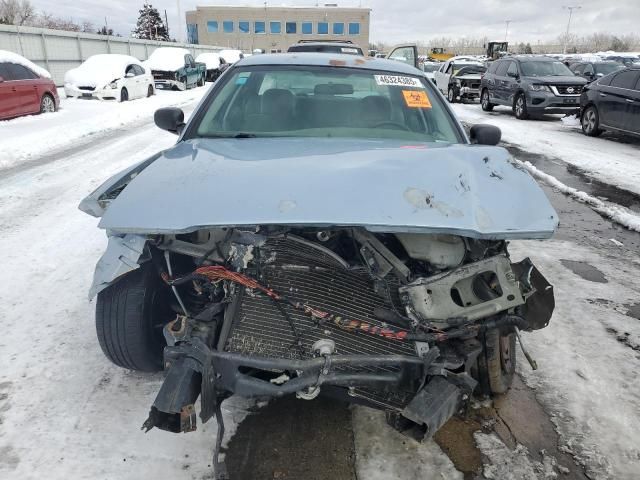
226,234 -> 415,366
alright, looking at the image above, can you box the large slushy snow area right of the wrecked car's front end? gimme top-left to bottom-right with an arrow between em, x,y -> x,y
510,240 -> 640,480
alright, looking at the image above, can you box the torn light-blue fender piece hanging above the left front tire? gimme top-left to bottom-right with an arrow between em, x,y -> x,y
89,235 -> 147,300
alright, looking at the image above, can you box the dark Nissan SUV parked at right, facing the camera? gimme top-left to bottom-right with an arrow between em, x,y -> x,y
480,55 -> 587,120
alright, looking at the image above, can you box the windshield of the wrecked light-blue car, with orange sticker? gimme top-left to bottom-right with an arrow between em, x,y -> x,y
188,66 -> 464,143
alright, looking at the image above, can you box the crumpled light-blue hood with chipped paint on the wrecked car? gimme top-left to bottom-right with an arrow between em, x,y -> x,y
96,138 -> 558,239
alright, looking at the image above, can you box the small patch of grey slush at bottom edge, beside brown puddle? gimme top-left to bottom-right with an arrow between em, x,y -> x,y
473,432 -> 558,480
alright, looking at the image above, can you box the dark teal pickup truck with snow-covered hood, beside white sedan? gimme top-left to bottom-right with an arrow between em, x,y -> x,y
143,47 -> 207,90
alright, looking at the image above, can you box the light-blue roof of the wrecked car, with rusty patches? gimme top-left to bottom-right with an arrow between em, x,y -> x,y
236,52 -> 423,75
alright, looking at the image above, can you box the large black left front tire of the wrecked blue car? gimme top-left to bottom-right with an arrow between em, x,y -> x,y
96,263 -> 175,372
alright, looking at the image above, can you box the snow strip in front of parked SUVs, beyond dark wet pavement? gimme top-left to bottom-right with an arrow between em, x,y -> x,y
451,104 -> 640,194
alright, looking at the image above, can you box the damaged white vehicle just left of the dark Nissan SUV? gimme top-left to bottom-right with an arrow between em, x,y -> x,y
434,56 -> 487,102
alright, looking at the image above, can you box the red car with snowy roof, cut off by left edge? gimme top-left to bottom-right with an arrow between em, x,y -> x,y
0,50 -> 60,120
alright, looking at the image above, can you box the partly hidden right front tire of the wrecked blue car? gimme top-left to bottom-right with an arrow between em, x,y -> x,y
478,329 -> 516,395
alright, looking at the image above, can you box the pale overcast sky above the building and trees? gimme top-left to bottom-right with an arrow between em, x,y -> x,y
32,0 -> 640,43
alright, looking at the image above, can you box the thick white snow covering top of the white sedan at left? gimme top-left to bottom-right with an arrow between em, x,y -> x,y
64,53 -> 144,88
